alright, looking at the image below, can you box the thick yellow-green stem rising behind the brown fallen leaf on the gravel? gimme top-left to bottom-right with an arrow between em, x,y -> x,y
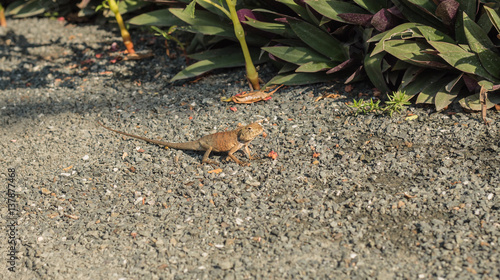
226,0 -> 260,90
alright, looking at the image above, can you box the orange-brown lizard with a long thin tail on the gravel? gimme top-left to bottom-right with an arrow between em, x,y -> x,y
97,122 -> 264,165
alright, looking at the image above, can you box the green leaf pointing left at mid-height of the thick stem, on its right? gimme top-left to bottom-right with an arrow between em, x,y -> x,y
262,46 -> 330,65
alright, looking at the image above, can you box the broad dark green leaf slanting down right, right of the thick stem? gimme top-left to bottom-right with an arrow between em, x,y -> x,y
288,19 -> 347,62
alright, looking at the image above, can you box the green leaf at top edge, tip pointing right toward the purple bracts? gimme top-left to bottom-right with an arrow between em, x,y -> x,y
306,0 -> 366,22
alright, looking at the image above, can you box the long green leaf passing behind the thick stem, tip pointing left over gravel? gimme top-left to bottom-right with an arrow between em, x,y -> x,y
171,47 -> 268,82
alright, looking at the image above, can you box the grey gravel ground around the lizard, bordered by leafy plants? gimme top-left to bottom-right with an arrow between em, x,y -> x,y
0,19 -> 500,279
